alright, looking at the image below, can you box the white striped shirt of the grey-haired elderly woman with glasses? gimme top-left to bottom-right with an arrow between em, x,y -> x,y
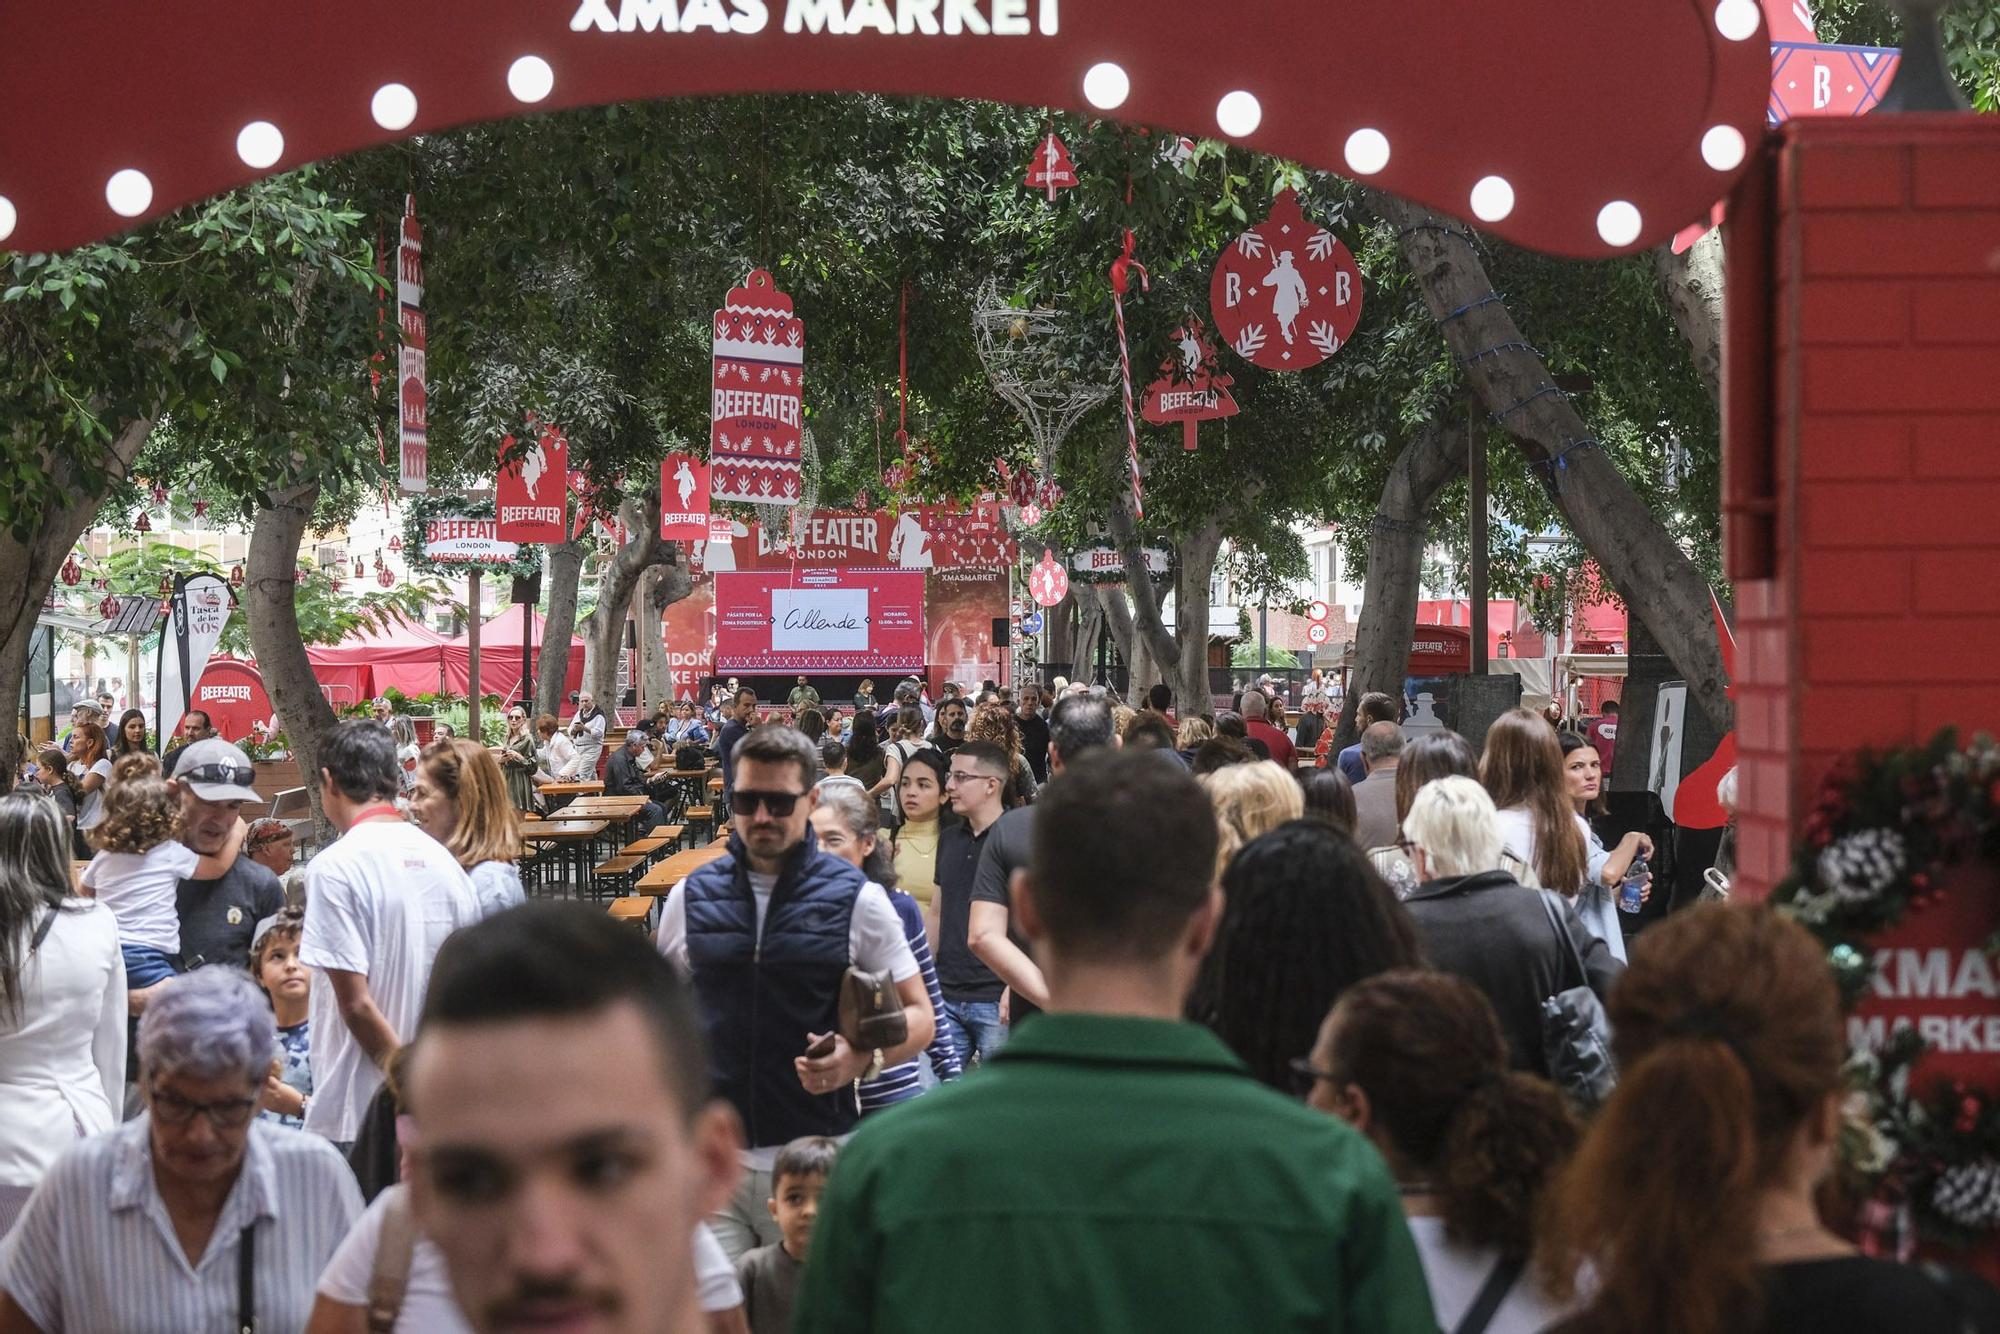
0,1116 -> 362,1334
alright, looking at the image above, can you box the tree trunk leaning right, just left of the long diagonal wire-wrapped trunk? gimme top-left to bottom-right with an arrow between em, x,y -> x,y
1334,422 -> 1466,746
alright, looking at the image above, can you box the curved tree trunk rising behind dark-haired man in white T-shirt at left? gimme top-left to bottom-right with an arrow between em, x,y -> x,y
242,482 -> 334,846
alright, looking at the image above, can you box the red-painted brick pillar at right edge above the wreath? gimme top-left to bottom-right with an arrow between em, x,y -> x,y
1724,116 -> 2000,898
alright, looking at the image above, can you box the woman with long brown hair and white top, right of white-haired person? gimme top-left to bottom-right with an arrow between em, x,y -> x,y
1480,708 -> 1626,962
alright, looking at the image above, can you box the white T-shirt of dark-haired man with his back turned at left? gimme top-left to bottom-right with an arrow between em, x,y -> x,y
298,820 -> 480,1144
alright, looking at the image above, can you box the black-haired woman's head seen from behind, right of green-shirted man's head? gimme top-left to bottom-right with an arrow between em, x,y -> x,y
1186,824 -> 1420,1094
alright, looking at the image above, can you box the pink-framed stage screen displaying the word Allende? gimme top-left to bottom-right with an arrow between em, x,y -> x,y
716,566 -> 924,676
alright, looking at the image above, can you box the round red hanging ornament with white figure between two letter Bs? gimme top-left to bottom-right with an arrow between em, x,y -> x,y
1208,190 -> 1362,370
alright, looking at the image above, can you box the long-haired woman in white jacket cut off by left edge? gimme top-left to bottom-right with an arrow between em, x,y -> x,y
0,792 -> 126,1234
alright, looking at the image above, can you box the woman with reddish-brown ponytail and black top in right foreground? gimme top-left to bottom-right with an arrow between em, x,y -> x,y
1540,904 -> 2000,1334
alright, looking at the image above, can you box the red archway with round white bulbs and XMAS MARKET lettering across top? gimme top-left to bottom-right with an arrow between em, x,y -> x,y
0,0 -> 1770,256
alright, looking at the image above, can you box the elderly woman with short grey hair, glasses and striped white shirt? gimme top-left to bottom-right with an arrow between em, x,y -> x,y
0,968 -> 362,1334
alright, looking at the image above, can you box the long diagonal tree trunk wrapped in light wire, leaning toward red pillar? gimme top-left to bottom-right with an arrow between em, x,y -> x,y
1376,196 -> 1734,726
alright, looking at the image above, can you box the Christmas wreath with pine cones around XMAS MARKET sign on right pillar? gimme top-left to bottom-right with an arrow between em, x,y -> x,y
1772,728 -> 2000,1256
